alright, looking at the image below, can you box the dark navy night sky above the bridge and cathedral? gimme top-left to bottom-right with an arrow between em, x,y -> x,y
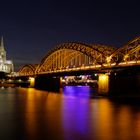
0,0 -> 140,70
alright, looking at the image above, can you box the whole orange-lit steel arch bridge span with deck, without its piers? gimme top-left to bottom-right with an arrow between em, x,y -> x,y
19,37 -> 140,75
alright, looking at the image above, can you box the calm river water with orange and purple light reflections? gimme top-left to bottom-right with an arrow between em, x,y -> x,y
0,86 -> 140,140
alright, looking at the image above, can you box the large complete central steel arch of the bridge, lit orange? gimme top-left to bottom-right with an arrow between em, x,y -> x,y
36,43 -> 114,73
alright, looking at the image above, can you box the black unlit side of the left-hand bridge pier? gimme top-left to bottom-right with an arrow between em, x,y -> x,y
35,75 -> 60,92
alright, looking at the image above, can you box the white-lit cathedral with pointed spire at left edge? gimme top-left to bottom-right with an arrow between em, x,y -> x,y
0,37 -> 14,73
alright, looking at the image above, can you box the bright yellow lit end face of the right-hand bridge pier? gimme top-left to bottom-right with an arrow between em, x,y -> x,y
98,74 -> 109,95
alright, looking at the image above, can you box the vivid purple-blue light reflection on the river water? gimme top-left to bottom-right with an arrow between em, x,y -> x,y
62,86 -> 90,140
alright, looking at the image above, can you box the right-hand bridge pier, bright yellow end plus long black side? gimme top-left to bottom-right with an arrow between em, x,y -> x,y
98,68 -> 140,96
